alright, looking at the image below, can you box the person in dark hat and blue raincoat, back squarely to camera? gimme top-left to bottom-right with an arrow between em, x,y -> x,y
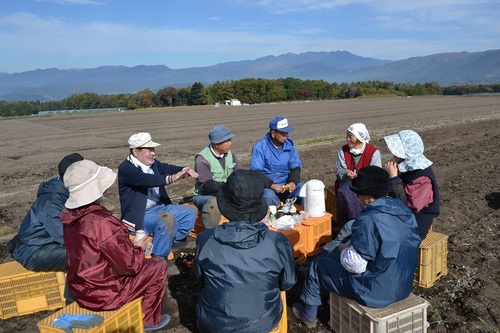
193,170 -> 296,333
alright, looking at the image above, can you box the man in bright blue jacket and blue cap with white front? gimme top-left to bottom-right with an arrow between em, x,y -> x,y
250,116 -> 303,206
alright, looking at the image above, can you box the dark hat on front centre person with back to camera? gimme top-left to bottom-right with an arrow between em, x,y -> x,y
217,169 -> 267,222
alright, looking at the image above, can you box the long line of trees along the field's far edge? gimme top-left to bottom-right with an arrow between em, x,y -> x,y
0,78 -> 500,117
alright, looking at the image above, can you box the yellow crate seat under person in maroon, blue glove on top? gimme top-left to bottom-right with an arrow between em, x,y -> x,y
37,297 -> 144,333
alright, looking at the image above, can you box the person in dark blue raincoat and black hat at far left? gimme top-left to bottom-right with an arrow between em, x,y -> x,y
8,153 -> 83,270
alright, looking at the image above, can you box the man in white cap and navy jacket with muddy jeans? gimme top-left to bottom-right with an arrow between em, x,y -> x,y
118,132 -> 198,274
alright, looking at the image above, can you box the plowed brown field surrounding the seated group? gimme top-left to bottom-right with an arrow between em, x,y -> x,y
0,96 -> 500,332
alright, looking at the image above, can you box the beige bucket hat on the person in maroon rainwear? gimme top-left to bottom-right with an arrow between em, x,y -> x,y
64,160 -> 116,209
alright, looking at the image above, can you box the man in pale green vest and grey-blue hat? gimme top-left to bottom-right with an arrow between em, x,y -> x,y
193,125 -> 241,229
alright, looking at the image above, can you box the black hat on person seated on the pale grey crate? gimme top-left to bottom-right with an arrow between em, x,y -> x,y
349,165 -> 391,197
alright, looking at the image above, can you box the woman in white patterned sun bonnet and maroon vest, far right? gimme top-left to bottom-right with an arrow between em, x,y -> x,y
384,130 -> 439,239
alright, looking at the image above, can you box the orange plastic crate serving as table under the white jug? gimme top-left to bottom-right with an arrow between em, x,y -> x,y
302,213 -> 332,256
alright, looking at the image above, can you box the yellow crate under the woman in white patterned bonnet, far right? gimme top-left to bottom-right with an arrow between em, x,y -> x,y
413,231 -> 448,288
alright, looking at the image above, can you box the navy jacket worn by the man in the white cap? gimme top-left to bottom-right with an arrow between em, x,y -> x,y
118,160 -> 183,230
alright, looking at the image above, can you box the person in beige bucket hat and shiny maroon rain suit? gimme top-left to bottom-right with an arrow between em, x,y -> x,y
59,160 -> 170,331
